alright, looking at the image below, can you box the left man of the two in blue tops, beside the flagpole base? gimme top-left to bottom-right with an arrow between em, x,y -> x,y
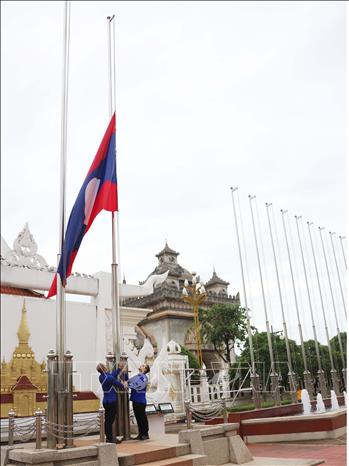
96,363 -> 124,443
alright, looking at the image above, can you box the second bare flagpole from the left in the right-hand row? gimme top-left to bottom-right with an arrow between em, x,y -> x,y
248,195 -> 281,405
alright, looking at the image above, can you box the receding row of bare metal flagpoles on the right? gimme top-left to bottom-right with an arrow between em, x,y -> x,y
231,188 -> 346,406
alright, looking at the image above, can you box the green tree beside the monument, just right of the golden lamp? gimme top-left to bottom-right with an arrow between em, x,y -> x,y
199,304 -> 247,364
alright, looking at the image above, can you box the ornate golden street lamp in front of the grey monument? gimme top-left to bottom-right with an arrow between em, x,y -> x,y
182,272 -> 207,369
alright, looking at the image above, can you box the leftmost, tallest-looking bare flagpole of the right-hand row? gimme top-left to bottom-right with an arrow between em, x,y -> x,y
230,188 -> 261,409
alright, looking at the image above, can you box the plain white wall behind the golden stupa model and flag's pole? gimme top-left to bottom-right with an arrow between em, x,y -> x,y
1,294 -> 99,390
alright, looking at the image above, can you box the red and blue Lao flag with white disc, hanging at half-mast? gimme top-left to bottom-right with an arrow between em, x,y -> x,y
47,113 -> 118,298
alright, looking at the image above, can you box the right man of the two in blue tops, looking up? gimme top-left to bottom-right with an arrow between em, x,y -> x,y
128,364 -> 150,440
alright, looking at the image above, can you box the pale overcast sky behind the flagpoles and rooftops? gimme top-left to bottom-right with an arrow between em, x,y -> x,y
1,1 -> 346,346
